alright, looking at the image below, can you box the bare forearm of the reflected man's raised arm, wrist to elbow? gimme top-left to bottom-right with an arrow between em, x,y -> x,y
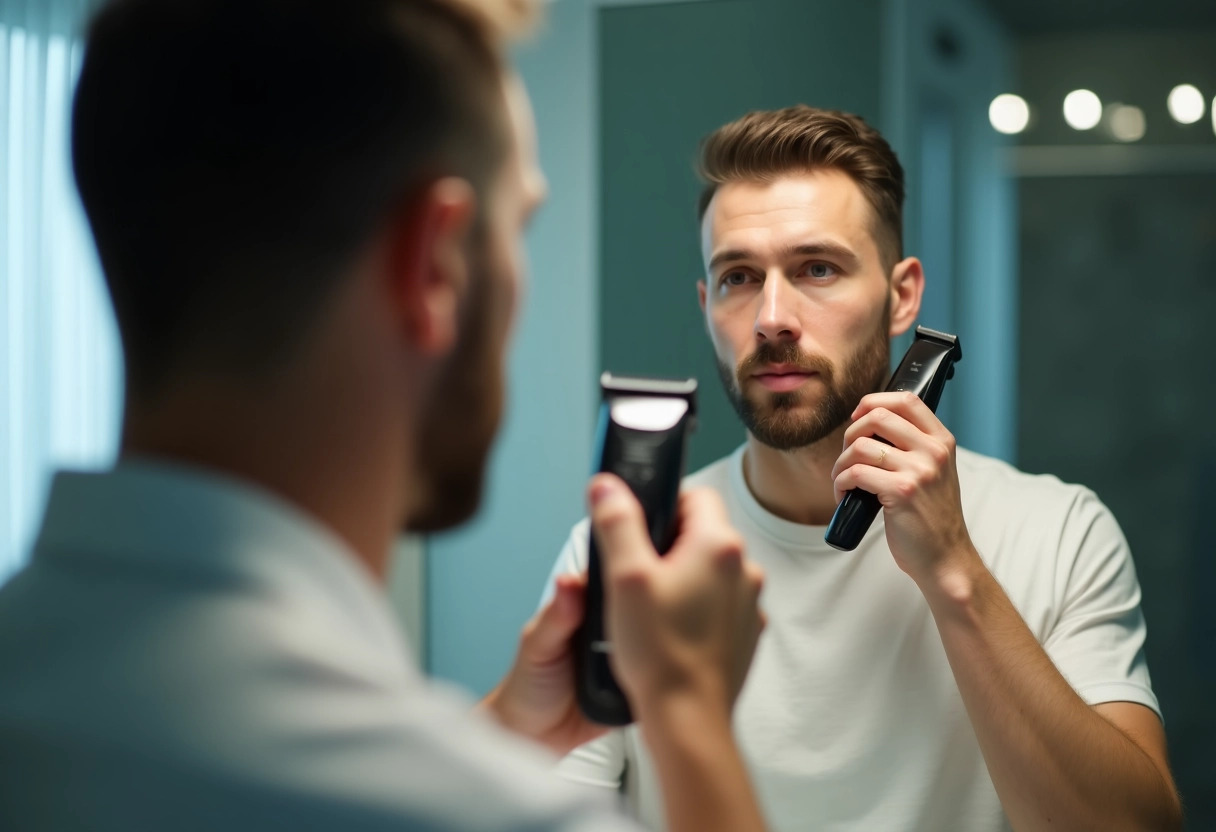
922,557 -> 1181,832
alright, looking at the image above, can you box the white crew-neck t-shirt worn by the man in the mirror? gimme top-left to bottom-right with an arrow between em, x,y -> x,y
554,448 -> 1160,832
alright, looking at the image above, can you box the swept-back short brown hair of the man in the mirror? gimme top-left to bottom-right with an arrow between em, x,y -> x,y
698,105 -> 903,270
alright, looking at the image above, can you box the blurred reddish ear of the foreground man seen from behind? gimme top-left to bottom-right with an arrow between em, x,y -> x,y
388,176 -> 477,355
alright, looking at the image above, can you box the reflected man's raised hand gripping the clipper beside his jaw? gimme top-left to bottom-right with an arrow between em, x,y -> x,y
832,393 -> 976,584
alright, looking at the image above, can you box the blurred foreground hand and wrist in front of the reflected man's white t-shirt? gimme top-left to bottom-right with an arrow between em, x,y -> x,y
589,474 -> 765,832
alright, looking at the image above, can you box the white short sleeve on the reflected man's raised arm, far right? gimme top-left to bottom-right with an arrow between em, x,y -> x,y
1043,489 -> 1161,715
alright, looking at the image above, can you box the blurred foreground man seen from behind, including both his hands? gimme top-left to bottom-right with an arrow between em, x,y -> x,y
0,0 -> 762,832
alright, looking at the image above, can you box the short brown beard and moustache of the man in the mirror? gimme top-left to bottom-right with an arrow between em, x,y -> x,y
717,300 -> 891,451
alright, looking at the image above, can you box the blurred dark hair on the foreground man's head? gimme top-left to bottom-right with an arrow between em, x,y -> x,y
72,0 -> 529,395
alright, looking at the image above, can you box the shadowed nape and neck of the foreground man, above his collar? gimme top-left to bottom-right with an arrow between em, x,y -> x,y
122,345 -> 411,581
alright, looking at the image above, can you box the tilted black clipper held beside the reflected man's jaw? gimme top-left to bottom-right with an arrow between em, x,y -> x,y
823,326 -> 963,551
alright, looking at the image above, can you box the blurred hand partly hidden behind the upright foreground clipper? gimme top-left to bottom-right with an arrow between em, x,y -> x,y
480,575 -> 606,754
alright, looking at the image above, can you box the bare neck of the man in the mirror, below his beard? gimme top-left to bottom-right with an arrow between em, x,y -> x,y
743,426 -> 845,525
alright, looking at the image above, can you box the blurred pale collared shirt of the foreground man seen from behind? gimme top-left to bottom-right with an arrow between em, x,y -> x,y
0,463 -> 636,832
